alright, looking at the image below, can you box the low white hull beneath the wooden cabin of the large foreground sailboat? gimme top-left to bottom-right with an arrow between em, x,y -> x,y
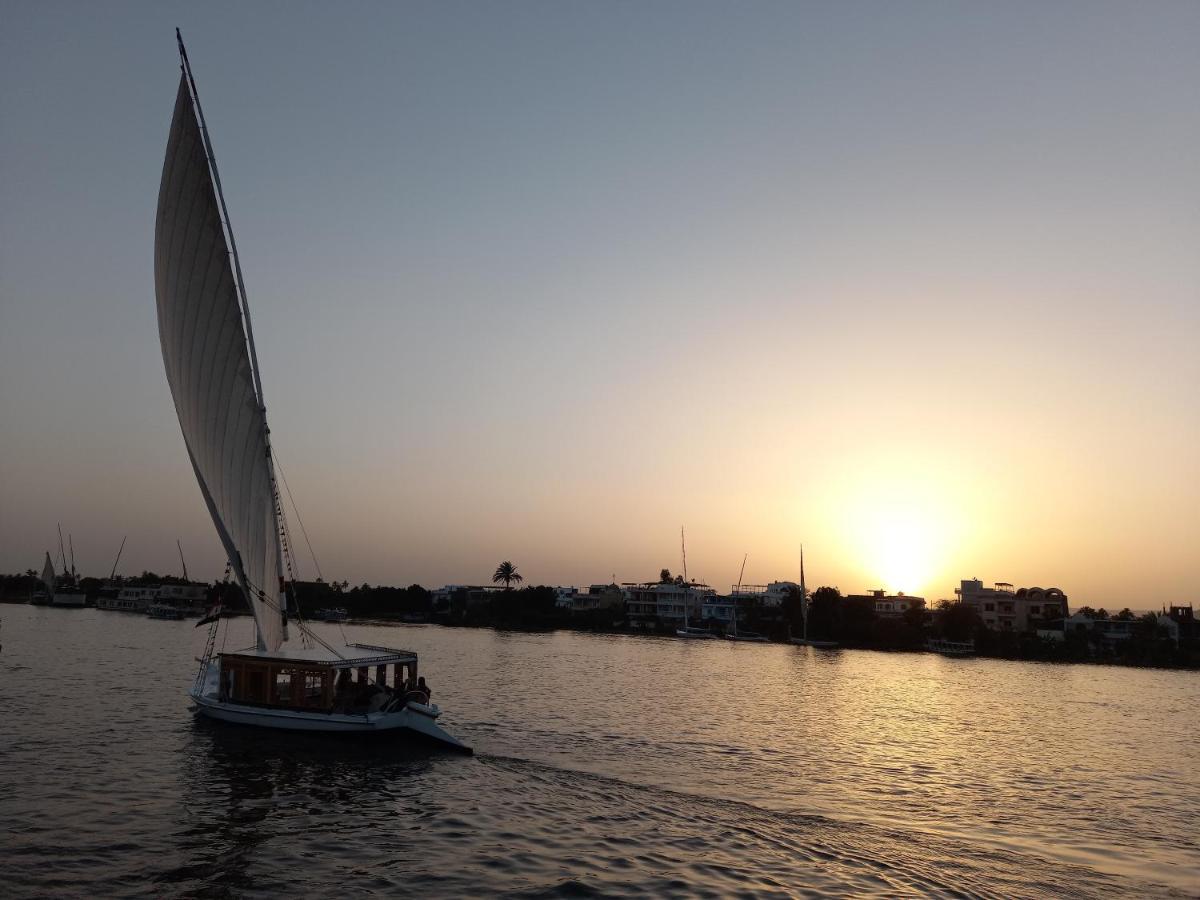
188,692 -> 472,754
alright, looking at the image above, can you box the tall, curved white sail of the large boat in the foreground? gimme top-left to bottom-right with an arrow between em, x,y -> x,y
155,76 -> 286,650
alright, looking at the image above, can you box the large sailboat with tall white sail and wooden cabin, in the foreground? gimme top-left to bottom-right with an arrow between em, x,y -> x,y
155,29 -> 470,752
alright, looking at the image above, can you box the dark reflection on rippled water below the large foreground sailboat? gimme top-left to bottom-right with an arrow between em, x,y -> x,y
162,716 -> 469,896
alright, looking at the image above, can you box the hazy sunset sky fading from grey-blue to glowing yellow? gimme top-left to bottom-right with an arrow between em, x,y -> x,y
0,0 -> 1200,608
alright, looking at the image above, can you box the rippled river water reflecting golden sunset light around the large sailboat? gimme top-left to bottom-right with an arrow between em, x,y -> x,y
0,606 -> 1200,898
